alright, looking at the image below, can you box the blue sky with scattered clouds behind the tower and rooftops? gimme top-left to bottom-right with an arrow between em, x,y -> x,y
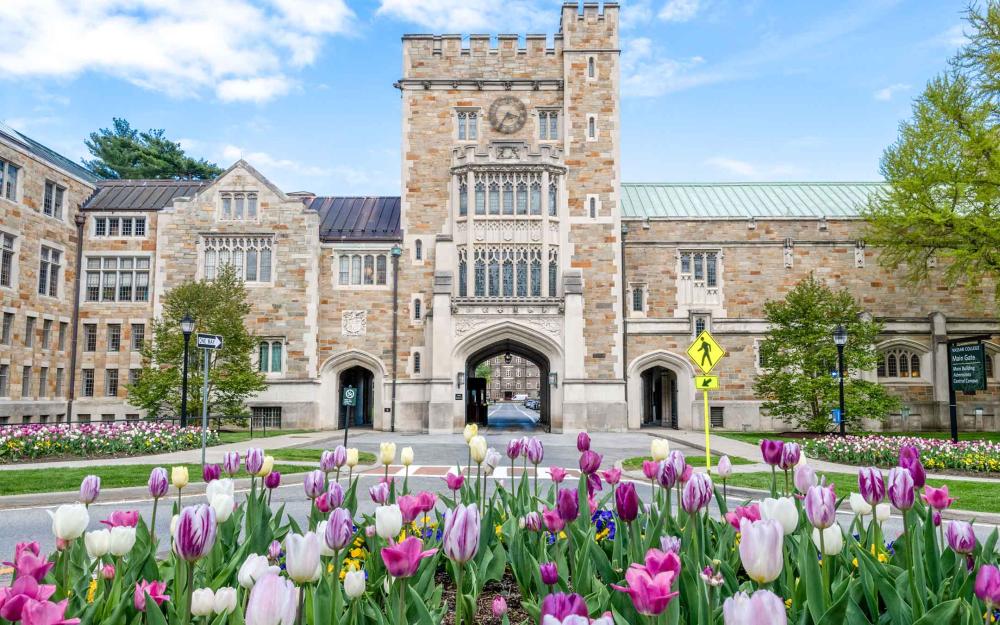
0,0 -> 966,195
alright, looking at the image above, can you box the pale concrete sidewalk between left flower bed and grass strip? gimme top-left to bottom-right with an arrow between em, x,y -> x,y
0,430 -> 343,471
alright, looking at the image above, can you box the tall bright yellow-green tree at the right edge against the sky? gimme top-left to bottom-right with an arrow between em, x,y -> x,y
864,0 -> 1000,300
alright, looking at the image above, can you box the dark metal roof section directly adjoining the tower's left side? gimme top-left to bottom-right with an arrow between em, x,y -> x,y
303,197 -> 402,241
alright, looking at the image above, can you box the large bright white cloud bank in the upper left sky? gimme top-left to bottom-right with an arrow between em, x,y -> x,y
0,0 -> 354,102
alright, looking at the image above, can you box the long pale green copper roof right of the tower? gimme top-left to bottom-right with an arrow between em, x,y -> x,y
622,182 -> 884,219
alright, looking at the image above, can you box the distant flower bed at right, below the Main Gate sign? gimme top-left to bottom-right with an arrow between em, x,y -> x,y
802,435 -> 1000,473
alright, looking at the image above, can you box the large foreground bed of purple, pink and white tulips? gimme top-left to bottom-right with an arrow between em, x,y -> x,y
0,431 -> 1000,625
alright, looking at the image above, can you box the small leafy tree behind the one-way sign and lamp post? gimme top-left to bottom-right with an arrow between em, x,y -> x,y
128,265 -> 266,422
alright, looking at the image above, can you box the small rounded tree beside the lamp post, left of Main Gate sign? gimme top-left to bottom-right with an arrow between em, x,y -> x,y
754,274 -> 899,432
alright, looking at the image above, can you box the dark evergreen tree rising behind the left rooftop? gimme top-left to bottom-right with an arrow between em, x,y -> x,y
83,117 -> 222,180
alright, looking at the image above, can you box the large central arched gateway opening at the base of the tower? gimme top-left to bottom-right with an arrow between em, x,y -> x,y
465,339 -> 552,431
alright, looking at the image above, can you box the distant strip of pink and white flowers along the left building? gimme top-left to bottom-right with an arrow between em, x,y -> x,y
0,421 -> 219,463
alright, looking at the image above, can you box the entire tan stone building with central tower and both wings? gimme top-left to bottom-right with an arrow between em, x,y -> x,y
0,2 -> 1000,432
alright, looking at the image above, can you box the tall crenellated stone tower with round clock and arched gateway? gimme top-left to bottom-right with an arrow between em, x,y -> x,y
396,2 -> 626,432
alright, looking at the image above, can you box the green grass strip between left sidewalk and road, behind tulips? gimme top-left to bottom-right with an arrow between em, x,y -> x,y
0,464 -> 310,495
